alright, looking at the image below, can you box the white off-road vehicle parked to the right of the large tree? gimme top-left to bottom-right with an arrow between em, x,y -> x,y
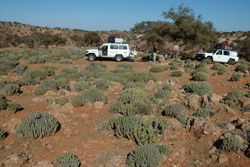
196,49 -> 239,64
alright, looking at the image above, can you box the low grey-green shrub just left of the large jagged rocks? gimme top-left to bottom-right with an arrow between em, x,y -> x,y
163,104 -> 185,118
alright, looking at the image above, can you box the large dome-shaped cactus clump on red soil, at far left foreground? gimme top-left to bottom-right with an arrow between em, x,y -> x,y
16,111 -> 60,139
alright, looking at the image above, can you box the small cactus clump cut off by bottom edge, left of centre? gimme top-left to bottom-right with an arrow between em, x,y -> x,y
55,152 -> 81,167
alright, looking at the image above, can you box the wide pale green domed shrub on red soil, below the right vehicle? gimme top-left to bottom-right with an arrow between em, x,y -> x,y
182,82 -> 213,96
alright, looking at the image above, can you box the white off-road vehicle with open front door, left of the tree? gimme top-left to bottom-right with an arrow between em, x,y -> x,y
86,40 -> 136,62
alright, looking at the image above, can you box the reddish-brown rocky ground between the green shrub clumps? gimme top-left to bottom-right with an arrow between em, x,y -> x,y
0,58 -> 250,167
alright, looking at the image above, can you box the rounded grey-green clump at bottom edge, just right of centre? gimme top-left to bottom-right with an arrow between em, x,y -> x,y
126,144 -> 168,167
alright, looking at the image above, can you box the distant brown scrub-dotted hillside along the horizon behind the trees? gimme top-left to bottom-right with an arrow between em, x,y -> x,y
0,21 -> 250,59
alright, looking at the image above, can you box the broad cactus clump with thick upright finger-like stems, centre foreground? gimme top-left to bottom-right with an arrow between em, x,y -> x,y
108,115 -> 169,145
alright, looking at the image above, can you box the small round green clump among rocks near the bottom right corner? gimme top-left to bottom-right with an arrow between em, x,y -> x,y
221,135 -> 243,151
